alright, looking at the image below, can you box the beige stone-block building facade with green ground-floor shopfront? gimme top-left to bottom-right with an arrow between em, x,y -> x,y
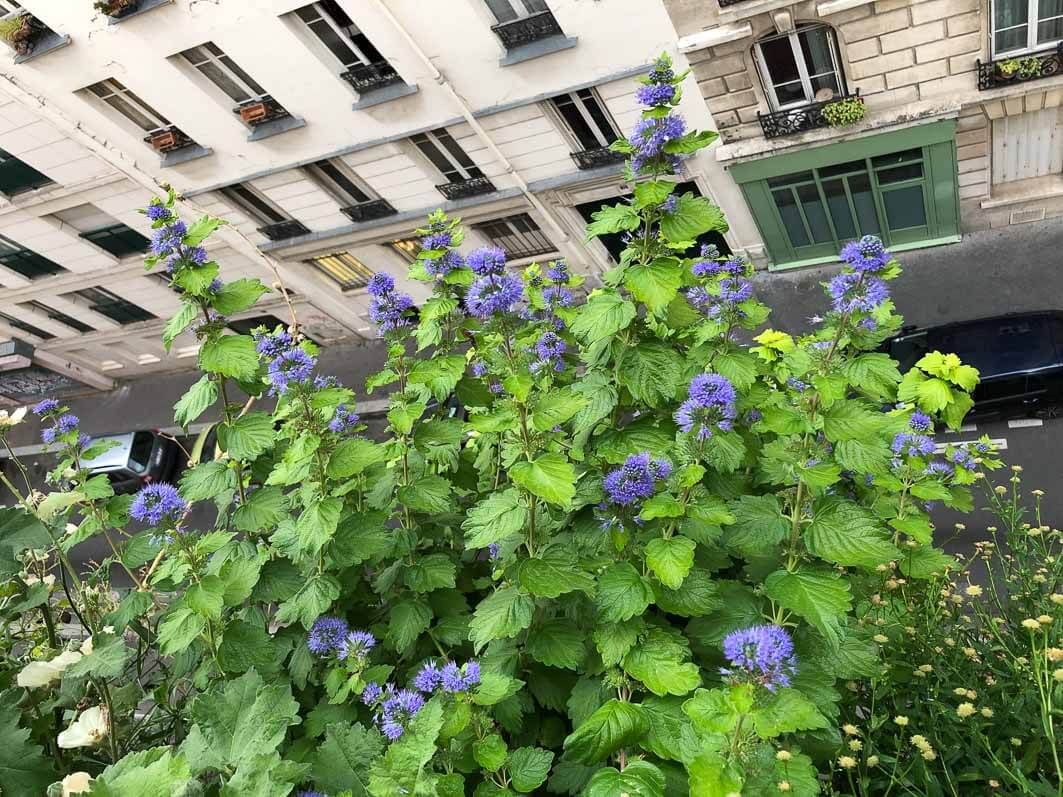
664,0 -> 1063,269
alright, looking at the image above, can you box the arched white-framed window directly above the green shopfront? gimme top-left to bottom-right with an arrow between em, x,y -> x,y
757,24 -> 845,111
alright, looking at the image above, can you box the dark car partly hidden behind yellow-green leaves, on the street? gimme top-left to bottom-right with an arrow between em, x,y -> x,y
887,310 -> 1063,420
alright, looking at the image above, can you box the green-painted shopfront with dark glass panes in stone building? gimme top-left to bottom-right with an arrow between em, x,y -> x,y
731,122 -> 958,268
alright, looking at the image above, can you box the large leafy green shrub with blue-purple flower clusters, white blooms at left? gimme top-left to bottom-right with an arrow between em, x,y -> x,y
0,51 -> 1051,797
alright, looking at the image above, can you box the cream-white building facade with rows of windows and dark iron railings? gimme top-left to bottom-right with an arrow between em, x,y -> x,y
0,0 -> 761,397
